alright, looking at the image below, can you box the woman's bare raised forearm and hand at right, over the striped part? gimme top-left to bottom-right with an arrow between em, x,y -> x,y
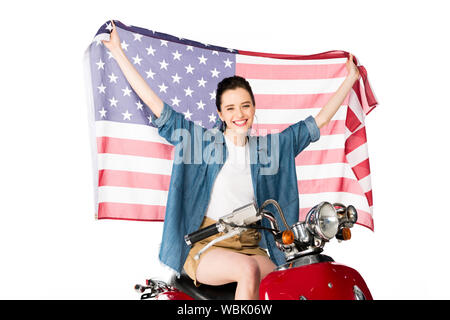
315,54 -> 359,129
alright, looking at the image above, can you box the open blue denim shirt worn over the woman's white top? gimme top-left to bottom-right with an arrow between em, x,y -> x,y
152,102 -> 320,274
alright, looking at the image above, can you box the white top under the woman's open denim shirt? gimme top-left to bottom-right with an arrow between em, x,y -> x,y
206,135 -> 253,220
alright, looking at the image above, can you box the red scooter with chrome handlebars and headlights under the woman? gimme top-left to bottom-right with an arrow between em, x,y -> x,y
135,199 -> 372,300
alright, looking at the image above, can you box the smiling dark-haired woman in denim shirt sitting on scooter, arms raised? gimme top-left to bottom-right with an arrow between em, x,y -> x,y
103,22 -> 359,299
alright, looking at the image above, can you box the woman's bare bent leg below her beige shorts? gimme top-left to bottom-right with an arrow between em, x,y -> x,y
196,248 -> 261,300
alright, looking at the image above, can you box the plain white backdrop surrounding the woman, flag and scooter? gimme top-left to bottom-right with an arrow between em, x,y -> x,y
0,0 -> 450,299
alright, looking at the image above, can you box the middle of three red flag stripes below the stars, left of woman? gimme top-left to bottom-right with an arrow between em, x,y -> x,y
98,169 -> 170,191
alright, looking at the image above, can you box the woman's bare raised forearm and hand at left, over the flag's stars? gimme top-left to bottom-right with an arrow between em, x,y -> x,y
102,20 -> 164,118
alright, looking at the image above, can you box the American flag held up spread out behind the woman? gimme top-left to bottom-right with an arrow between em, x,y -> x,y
85,21 -> 377,230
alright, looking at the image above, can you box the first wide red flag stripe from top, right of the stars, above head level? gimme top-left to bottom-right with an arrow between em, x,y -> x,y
236,61 -> 347,80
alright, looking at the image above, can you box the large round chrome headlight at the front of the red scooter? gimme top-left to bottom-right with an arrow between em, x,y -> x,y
306,202 -> 339,241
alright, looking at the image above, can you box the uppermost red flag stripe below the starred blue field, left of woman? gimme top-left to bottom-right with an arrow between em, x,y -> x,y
97,137 -> 174,160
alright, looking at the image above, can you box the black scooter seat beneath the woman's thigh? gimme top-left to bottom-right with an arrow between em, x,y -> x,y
170,269 -> 237,300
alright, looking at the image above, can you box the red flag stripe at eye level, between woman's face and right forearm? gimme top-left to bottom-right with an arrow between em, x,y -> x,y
255,92 -> 350,109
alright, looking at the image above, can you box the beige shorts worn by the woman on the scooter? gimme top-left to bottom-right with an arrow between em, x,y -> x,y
184,216 -> 269,287
